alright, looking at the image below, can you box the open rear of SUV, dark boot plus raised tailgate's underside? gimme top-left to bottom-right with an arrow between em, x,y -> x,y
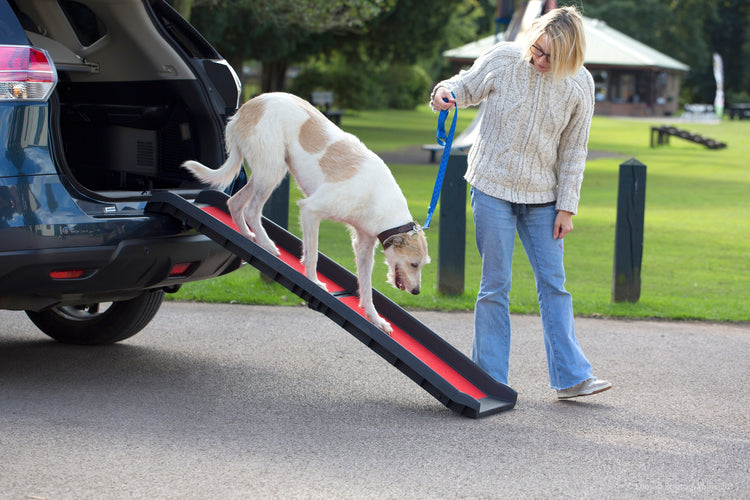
14,0 -> 236,199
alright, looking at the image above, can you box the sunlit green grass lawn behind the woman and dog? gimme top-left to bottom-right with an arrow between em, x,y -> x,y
172,107 -> 750,321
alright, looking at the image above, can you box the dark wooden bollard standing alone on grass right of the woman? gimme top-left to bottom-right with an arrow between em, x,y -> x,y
612,158 -> 646,302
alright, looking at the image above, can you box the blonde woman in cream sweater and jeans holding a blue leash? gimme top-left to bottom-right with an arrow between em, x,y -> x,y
431,7 -> 612,399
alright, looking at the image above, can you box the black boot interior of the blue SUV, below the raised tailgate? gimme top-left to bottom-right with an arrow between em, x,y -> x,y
53,82 -> 207,194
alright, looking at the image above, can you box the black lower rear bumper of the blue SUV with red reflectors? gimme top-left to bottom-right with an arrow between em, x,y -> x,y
0,234 -> 241,310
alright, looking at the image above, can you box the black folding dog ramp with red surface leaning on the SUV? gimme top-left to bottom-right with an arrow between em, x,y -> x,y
146,191 -> 517,418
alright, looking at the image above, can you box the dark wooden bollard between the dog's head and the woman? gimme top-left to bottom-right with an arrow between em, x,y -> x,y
437,152 -> 467,295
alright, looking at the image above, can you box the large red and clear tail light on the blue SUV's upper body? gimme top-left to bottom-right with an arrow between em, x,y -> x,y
0,45 -> 57,101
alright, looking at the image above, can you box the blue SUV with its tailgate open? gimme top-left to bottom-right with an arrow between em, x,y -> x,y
0,0 -> 247,344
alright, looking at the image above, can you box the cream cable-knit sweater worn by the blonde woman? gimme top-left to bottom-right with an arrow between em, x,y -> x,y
433,42 -> 594,213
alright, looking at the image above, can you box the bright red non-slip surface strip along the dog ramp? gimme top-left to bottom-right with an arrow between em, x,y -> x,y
201,206 -> 487,400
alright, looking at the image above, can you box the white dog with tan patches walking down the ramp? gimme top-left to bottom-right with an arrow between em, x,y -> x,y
183,93 -> 430,333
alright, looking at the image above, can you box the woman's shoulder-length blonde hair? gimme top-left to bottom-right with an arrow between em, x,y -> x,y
522,7 -> 586,78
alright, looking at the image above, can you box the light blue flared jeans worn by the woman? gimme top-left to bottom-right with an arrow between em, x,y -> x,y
471,187 -> 592,389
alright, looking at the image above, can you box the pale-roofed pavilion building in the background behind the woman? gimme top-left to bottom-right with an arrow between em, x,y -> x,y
443,17 -> 690,116
